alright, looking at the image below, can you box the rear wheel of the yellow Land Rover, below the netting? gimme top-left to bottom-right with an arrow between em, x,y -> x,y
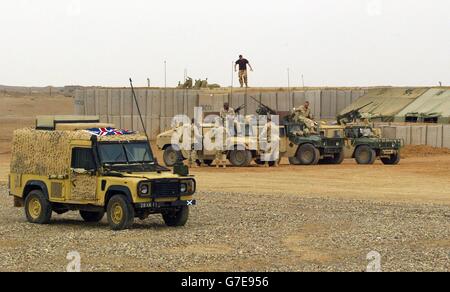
25,190 -> 52,224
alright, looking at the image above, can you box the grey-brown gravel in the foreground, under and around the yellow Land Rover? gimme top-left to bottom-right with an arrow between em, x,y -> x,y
0,185 -> 450,271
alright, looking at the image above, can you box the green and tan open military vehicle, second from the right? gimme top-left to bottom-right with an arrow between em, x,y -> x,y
280,122 -> 344,165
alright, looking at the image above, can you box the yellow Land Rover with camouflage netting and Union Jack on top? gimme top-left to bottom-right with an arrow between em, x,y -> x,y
9,117 -> 196,230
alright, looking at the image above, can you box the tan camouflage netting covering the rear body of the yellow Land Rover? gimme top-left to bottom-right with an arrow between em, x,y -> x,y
11,128 -> 91,176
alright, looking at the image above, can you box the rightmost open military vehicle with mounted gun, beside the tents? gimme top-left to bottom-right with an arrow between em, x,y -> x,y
324,103 -> 404,165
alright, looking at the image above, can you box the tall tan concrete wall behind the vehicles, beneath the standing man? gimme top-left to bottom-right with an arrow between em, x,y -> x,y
74,88 -> 367,139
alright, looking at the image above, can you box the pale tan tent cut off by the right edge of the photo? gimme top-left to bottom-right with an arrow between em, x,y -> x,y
395,88 -> 450,124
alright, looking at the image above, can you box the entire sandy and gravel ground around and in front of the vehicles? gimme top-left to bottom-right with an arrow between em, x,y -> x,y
0,97 -> 450,271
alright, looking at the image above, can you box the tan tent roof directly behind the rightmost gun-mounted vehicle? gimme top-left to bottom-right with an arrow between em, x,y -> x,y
340,88 -> 428,122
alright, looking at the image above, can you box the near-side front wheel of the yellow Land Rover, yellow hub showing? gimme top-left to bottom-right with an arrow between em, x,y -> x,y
107,195 -> 134,230
